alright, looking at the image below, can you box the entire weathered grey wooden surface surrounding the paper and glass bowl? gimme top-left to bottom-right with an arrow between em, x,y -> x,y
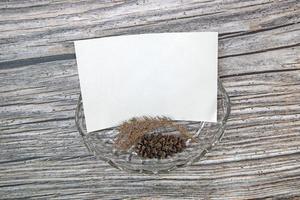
0,0 -> 300,199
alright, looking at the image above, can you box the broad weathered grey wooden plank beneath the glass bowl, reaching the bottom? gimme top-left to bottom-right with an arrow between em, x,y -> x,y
0,57 -> 300,199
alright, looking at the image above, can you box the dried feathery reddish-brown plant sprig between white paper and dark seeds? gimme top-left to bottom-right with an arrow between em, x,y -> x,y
115,116 -> 195,150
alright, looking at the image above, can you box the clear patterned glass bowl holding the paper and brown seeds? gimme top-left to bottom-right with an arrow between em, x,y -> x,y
75,80 -> 230,174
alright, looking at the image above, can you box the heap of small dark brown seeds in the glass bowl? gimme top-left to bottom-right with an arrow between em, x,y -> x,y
135,134 -> 186,159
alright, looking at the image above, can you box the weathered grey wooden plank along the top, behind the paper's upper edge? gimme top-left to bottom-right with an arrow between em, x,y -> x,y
0,1 -> 300,61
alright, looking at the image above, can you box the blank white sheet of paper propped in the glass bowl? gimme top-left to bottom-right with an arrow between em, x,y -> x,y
75,32 -> 218,132
